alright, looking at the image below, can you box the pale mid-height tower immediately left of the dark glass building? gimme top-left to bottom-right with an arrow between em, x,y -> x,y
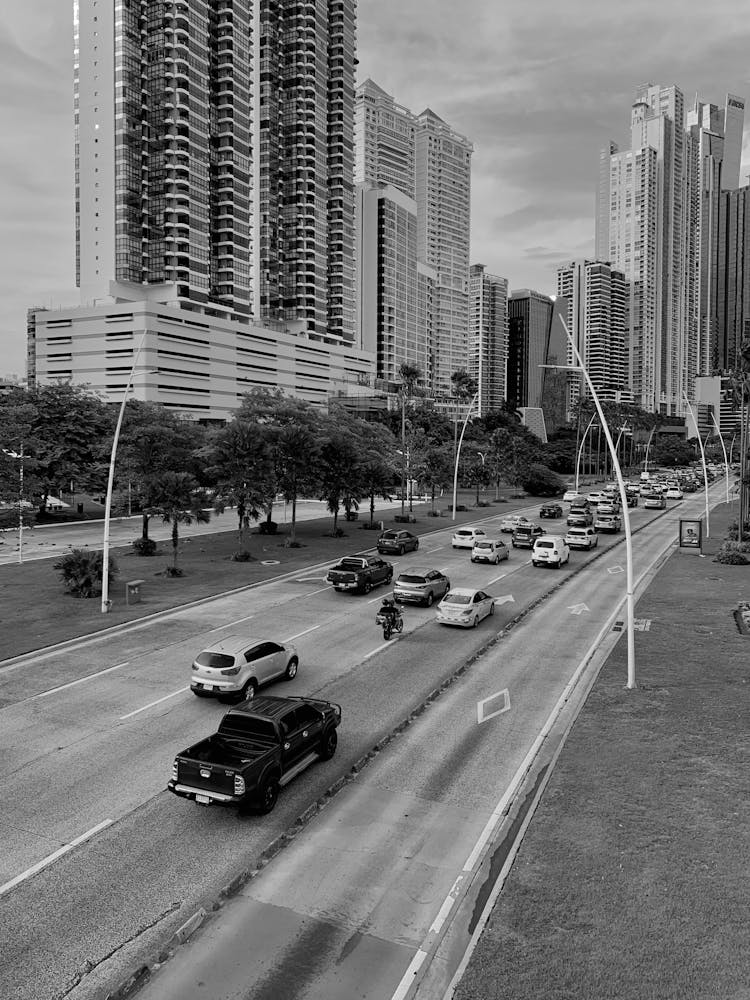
467,264 -> 508,416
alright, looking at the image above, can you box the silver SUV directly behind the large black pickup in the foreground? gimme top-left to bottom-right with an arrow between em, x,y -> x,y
190,635 -> 299,701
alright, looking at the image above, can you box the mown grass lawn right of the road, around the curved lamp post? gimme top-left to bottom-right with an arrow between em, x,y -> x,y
454,504 -> 750,1000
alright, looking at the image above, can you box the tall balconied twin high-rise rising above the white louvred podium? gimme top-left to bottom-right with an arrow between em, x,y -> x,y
74,0 -> 356,344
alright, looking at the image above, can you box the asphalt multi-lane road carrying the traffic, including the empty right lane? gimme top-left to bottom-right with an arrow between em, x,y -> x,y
0,498 -> 720,1000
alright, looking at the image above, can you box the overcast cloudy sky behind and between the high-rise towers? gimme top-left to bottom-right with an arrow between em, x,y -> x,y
0,0 -> 750,375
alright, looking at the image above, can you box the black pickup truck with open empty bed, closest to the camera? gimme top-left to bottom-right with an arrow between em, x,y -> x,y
167,696 -> 341,813
